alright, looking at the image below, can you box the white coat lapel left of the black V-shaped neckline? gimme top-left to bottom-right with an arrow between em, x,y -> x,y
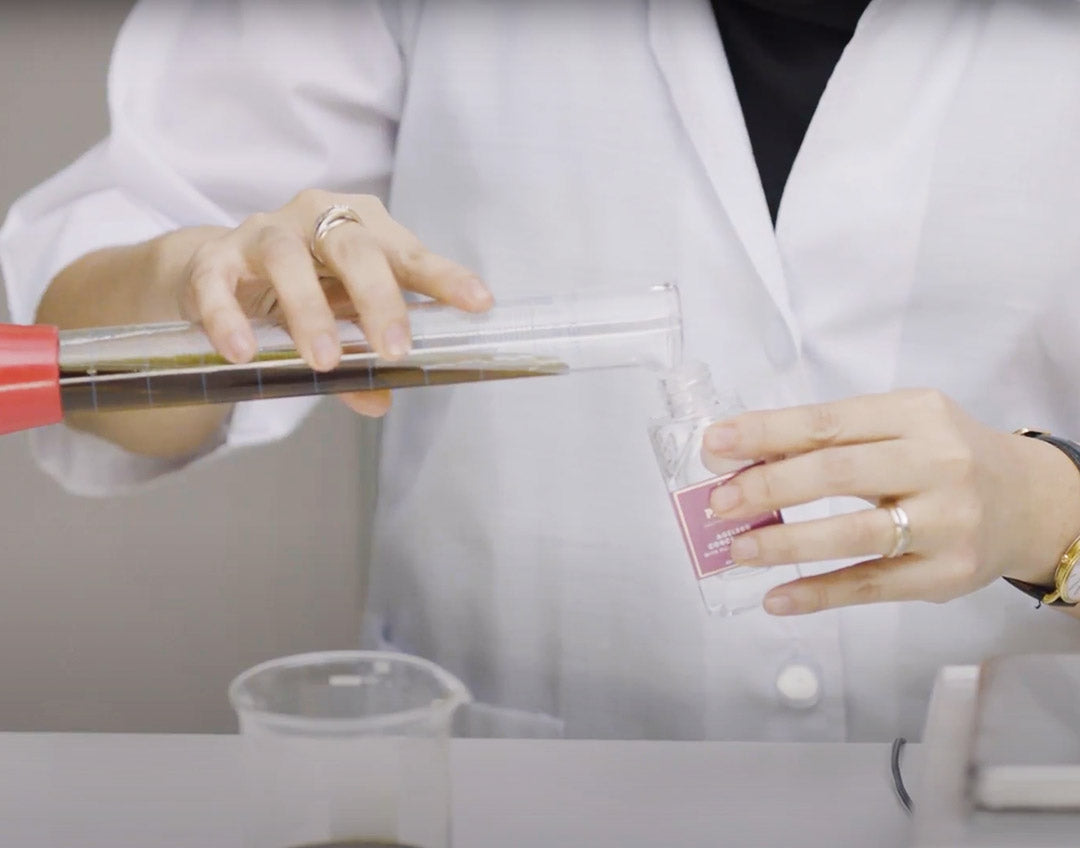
649,0 -> 797,338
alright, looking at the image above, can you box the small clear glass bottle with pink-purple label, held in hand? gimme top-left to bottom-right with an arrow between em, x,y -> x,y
649,362 -> 798,616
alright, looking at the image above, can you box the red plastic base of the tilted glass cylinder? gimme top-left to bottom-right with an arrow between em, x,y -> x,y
0,324 -> 64,433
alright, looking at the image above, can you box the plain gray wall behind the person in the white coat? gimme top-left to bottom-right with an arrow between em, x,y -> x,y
0,0 -> 374,731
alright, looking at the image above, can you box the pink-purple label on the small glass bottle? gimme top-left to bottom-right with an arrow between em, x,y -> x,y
672,469 -> 783,580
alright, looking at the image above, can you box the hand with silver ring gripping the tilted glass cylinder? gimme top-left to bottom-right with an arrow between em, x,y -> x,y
179,189 -> 492,416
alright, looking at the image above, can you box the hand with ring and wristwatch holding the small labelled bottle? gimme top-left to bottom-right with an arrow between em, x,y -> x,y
703,390 -> 1080,615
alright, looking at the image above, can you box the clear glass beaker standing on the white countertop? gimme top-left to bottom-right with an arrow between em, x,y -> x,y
229,650 -> 472,848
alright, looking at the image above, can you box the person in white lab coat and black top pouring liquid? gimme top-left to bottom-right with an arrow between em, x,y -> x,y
0,0 -> 1080,741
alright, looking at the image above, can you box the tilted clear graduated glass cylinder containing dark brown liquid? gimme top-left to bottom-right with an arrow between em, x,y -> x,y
48,285 -> 681,412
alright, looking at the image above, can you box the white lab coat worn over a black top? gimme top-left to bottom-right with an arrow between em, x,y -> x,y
2,0 -> 1080,741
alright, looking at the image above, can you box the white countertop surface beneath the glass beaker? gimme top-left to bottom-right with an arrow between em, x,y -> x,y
0,733 -> 919,848
